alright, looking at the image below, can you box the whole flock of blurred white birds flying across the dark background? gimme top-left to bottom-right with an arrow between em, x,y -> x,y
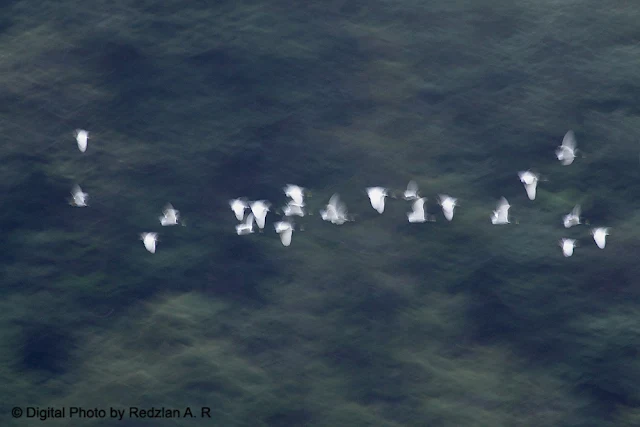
70,129 -> 609,257
